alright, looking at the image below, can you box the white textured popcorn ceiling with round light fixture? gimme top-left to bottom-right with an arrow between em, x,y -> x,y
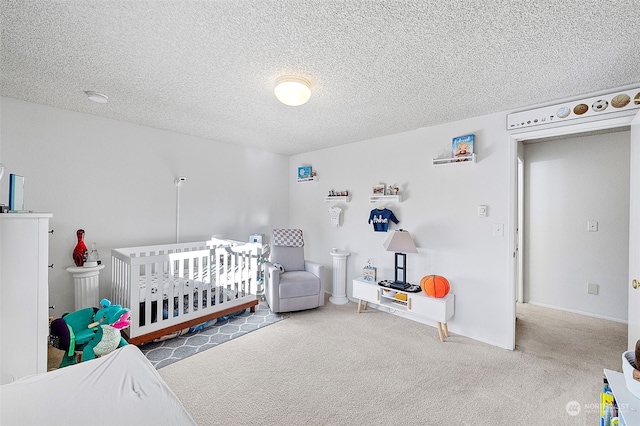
0,0 -> 640,154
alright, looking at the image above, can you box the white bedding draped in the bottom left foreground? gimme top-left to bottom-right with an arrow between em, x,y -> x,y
0,345 -> 195,426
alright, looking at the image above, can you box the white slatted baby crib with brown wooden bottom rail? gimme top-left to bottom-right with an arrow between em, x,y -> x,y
111,238 -> 262,344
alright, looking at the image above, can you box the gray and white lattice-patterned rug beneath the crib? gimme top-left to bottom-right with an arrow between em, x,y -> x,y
139,302 -> 285,370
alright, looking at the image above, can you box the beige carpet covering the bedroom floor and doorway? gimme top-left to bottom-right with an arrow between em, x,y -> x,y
159,303 -> 626,426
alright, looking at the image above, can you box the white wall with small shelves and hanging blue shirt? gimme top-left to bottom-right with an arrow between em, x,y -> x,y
289,113 -> 515,348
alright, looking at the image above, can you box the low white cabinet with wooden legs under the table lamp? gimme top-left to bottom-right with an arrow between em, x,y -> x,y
353,279 -> 455,342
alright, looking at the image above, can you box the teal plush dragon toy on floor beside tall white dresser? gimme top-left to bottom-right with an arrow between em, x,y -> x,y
49,299 -> 130,368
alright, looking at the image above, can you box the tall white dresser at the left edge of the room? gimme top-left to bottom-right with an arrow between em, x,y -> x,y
0,213 -> 52,384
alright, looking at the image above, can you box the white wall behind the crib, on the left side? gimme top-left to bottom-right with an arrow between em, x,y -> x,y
0,98 -> 289,315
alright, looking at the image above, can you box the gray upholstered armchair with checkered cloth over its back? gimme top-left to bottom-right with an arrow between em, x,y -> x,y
265,229 -> 324,312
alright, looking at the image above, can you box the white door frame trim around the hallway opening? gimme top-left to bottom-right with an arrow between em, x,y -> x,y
507,109 -> 638,350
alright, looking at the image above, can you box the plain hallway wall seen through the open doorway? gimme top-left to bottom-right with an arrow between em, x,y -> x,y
523,131 -> 630,321
